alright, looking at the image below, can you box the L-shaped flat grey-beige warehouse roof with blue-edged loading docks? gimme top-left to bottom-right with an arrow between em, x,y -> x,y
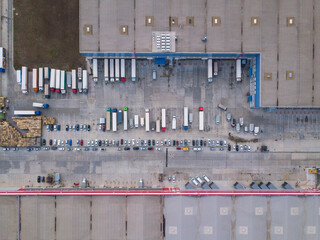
79,0 -> 320,107
